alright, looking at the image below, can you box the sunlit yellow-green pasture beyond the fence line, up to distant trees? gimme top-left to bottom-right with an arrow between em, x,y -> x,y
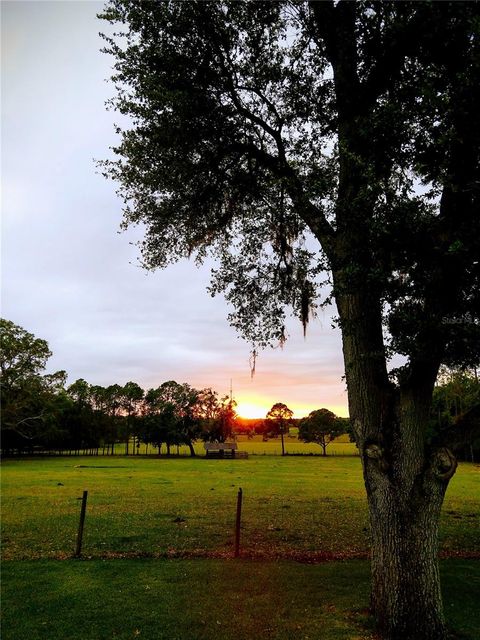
2,456 -> 480,560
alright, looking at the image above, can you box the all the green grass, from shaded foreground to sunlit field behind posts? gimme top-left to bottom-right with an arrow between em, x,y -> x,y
2,456 -> 480,640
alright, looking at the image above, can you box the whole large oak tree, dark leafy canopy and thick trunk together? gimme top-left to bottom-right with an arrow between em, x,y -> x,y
102,0 -> 480,640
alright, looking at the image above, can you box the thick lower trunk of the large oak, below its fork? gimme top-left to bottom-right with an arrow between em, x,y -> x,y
364,440 -> 450,640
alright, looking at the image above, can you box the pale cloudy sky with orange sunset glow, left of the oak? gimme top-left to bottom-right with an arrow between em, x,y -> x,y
1,0 -> 347,418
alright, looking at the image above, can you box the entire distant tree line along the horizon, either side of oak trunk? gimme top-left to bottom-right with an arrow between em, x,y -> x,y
0,319 -> 480,461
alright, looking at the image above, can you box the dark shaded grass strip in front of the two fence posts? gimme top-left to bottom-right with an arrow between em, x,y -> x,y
2,559 -> 480,640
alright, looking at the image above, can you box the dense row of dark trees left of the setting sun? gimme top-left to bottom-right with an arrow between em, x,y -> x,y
0,319 -> 236,456
